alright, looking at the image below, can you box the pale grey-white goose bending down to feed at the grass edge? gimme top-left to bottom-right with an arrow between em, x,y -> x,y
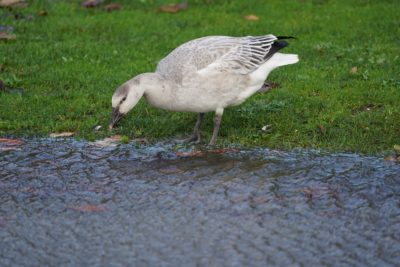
109,34 -> 299,145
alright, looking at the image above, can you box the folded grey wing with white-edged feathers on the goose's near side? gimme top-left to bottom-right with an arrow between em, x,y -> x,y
157,34 -> 279,82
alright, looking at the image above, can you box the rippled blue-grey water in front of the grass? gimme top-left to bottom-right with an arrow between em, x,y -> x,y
0,139 -> 400,266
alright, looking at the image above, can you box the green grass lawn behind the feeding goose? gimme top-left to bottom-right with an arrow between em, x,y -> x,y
0,0 -> 400,154
